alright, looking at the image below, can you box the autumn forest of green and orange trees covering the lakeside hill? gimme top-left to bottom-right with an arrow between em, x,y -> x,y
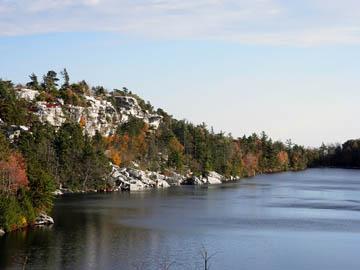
0,69 -> 348,231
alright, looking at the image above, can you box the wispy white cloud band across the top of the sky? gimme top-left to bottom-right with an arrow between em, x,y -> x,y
0,0 -> 360,47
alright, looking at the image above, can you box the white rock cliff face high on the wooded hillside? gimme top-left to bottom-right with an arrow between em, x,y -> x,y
18,89 -> 162,136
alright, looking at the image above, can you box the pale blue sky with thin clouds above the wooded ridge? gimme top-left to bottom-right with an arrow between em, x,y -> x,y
0,0 -> 360,146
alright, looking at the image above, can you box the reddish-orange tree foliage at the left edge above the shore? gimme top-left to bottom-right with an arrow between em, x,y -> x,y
0,152 -> 29,194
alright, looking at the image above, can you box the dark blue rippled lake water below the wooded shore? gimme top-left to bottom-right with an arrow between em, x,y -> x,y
0,169 -> 360,270
